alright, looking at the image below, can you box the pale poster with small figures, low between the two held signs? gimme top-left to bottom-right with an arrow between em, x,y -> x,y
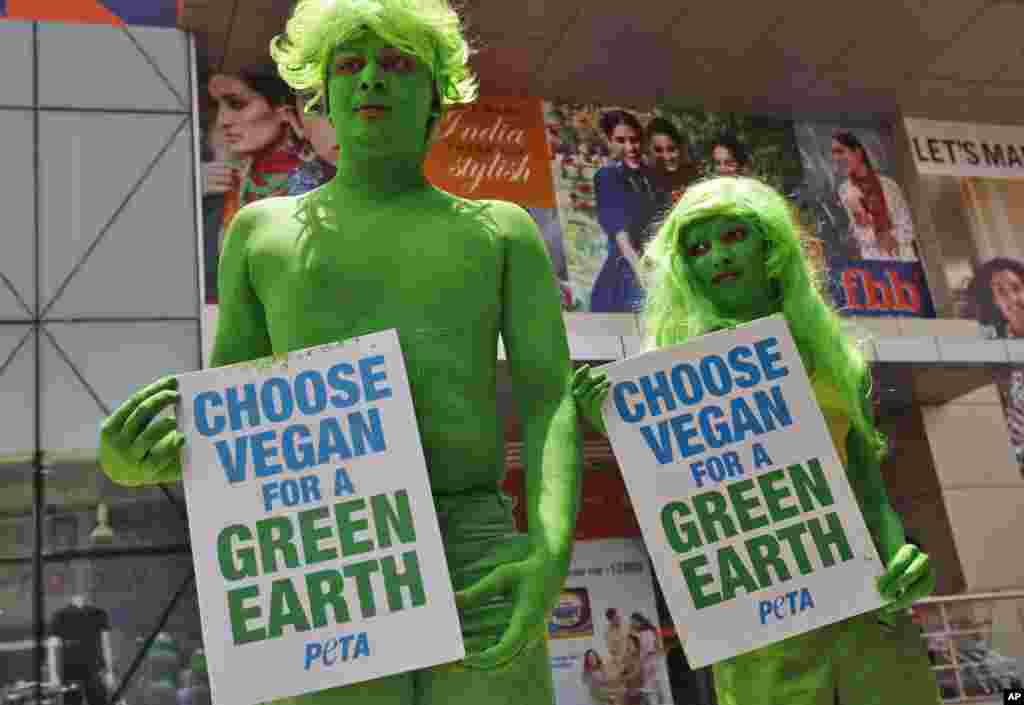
548,539 -> 673,705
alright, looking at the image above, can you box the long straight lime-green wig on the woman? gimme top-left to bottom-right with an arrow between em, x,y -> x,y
643,176 -> 886,460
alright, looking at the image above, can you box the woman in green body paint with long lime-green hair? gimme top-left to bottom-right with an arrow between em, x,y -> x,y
573,176 -> 939,705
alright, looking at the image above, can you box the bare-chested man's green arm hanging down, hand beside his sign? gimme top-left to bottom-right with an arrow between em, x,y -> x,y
458,203 -> 581,668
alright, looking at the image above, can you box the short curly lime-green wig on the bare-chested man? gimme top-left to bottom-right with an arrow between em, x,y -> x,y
270,0 -> 477,110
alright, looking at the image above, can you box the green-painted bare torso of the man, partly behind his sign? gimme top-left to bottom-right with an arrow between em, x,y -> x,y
237,190 -> 512,494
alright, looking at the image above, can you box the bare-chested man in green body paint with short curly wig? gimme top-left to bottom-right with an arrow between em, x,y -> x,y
100,0 -> 581,705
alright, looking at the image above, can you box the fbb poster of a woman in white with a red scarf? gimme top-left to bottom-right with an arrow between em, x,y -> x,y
794,123 -> 935,318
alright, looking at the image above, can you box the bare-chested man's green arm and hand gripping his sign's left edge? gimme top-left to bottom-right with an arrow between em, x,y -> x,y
99,207 -> 270,487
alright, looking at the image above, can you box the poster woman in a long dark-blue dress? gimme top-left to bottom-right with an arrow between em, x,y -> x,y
590,110 -> 654,313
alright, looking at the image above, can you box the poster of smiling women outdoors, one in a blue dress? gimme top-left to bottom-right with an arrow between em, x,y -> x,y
545,102 -> 801,313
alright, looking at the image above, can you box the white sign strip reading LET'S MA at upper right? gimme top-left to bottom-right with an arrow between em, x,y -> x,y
904,118 -> 1024,178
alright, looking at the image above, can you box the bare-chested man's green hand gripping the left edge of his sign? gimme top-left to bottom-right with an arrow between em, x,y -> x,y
99,377 -> 185,487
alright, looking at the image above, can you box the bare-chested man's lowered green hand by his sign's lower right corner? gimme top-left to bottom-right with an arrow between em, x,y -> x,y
456,551 -> 569,669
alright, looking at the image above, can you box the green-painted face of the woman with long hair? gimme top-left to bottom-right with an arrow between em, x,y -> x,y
680,216 -> 775,321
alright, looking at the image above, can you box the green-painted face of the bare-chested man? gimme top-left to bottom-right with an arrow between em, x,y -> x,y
328,33 -> 434,156
